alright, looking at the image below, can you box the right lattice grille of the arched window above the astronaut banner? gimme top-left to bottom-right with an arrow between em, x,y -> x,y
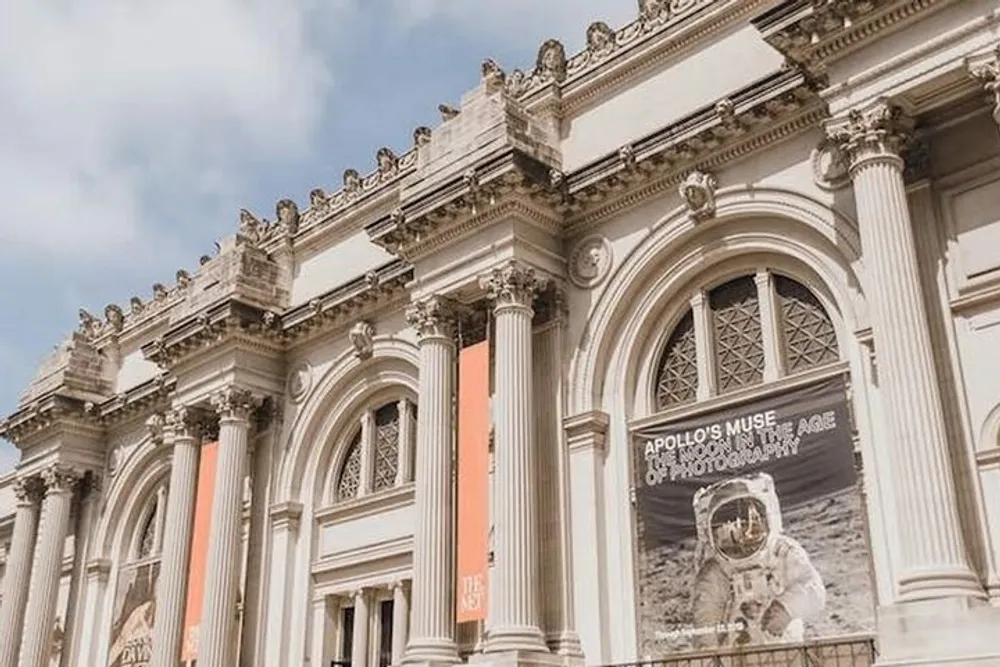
774,276 -> 840,372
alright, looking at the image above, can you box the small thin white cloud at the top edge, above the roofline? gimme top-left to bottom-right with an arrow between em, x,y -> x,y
390,0 -> 639,50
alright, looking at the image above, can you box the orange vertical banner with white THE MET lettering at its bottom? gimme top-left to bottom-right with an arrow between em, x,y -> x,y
456,341 -> 490,623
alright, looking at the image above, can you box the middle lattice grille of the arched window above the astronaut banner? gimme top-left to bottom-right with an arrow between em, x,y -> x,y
709,277 -> 764,393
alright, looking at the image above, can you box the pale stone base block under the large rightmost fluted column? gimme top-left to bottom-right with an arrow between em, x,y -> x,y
875,597 -> 1000,667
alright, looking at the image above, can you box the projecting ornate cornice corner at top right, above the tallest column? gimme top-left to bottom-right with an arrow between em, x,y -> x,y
752,0 -> 958,74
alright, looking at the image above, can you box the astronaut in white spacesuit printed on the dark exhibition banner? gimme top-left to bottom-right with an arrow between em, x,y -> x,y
692,473 -> 826,648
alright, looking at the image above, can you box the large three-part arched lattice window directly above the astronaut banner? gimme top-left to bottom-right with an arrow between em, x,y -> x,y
654,271 -> 840,410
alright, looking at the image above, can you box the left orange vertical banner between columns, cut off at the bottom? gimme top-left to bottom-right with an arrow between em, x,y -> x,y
181,442 -> 219,667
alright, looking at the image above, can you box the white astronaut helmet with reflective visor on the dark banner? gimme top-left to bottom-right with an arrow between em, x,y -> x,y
693,473 -> 782,564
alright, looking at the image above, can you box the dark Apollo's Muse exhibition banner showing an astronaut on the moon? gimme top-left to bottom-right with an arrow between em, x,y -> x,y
633,377 -> 874,656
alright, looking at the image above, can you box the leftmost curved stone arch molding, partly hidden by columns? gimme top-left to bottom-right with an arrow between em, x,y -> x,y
94,438 -> 170,563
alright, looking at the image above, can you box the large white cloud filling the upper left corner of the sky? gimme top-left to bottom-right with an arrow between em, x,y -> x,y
0,0 -> 353,261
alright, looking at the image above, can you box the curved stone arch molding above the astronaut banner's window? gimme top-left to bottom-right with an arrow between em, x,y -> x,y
570,186 -> 866,414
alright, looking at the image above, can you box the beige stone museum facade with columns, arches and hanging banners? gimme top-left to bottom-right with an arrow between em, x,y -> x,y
0,0 -> 1000,667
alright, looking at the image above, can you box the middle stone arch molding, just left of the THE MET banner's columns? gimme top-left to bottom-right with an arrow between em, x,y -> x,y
276,336 -> 418,505
